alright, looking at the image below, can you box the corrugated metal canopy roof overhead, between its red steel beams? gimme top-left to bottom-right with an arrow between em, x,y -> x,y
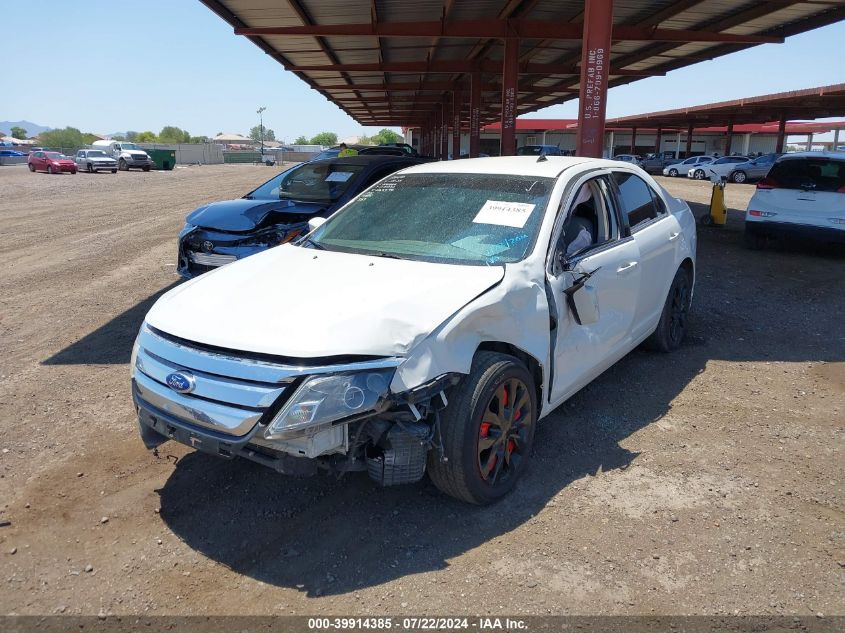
201,0 -> 845,125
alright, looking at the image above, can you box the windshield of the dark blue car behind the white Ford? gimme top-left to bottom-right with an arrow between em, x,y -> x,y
246,162 -> 364,203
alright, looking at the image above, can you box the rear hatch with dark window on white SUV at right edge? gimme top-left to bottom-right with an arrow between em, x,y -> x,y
753,156 -> 845,228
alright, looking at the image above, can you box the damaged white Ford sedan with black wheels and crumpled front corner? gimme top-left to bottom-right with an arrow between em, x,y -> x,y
132,156 -> 696,504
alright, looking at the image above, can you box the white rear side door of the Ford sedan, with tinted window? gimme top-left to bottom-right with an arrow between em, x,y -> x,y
613,170 -> 681,340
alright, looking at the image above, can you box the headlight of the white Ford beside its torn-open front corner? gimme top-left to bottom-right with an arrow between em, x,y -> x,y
264,369 -> 395,439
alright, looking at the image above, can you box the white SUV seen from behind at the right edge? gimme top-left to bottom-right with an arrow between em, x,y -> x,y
745,152 -> 845,248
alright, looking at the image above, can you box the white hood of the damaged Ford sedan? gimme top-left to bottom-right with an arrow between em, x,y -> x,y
146,244 -> 504,358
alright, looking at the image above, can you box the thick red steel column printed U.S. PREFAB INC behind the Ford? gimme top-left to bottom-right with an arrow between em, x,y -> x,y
575,0 -> 613,158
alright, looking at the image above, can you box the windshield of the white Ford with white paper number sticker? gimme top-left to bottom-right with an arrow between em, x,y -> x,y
305,174 -> 554,266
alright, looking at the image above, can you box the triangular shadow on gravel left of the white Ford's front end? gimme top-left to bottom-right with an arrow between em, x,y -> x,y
41,281 -> 180,365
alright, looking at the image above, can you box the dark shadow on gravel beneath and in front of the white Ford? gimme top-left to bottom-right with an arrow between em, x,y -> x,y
158,336 -> 706,596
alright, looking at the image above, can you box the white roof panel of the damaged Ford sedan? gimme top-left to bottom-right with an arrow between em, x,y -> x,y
403,156 -> 608,178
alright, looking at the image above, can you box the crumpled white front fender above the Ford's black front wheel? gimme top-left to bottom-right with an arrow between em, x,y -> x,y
391,261 -> 550,393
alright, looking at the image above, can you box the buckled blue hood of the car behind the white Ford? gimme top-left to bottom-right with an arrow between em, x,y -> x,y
185,198 -> 326,232
